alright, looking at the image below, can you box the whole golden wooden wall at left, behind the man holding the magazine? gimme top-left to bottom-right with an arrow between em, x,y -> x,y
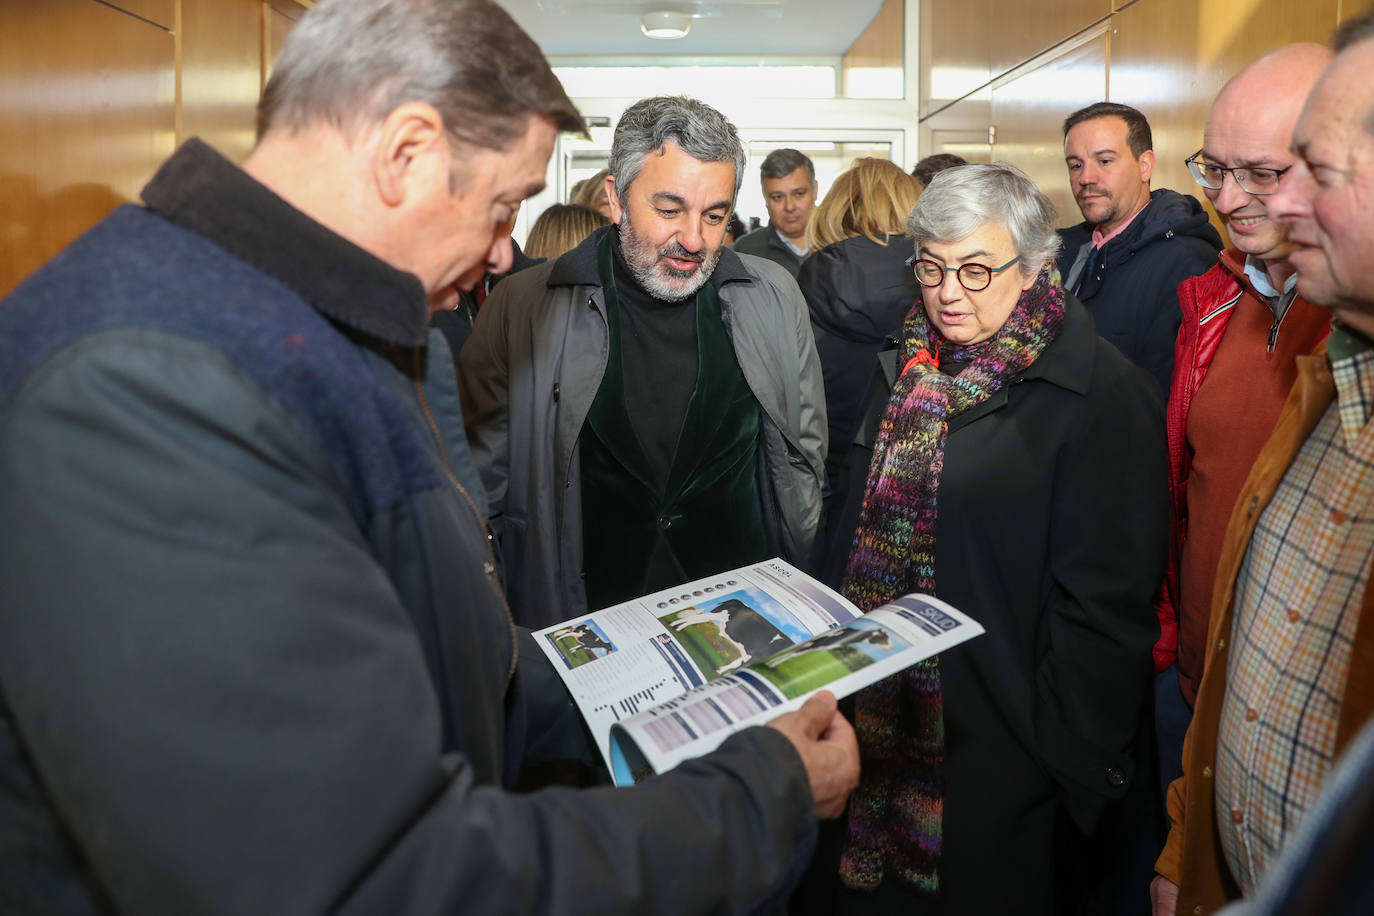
0,0 -> 312,295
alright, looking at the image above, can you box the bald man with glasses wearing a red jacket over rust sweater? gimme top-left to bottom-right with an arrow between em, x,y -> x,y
1156,44 -> 1331,840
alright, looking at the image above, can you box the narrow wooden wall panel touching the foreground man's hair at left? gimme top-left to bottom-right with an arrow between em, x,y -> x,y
179,0 -> 262,162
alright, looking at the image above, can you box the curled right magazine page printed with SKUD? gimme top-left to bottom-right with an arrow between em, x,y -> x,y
610,595 -> 984,786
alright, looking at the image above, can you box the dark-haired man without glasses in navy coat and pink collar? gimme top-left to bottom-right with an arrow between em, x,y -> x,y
1058,102 -> 1221,398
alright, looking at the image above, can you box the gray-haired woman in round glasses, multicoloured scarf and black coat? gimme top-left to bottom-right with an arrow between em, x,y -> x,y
794,165 -> 1168,915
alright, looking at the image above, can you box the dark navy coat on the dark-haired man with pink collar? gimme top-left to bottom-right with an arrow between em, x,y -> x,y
1058,188 -> 1221,398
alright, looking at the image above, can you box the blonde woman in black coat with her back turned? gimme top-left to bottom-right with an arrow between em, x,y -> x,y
797,158 -> 921,588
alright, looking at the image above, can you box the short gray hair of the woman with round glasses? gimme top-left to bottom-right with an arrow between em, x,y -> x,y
907,162 -> 1059,276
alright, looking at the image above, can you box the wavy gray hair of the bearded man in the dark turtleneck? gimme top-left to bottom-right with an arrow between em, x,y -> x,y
609,96 -> 745,201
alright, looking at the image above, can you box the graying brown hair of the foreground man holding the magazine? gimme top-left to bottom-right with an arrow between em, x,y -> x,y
257,0 -> 585,150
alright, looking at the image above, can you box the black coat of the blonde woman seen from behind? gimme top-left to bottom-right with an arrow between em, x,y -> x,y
797,235 -> 921,586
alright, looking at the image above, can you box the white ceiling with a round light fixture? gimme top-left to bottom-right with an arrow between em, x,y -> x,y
497,0 -> 882,58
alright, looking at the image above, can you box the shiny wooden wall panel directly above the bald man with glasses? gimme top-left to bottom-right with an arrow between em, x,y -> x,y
1107,0 -> 1351,240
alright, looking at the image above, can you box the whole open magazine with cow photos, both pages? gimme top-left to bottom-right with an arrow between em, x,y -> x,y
534,559 -> 982,786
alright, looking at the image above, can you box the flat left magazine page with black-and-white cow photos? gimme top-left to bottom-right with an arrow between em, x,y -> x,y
534,559 -> 859,773
